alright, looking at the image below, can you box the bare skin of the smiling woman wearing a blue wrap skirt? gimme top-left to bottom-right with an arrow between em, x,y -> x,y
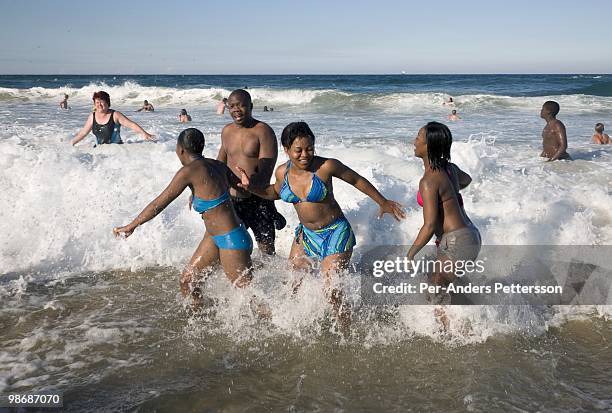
237,136 -> 405,326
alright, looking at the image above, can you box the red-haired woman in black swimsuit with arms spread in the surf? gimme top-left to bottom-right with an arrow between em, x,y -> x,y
70,90 -> 155,146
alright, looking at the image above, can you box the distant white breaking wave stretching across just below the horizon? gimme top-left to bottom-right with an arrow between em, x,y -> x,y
0,81 -> 612,112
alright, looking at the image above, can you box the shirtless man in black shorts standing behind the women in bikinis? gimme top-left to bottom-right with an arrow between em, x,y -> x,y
217,89 -> 286,255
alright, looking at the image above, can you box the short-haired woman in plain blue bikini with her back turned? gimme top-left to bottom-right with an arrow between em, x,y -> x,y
113,128 -> 253,303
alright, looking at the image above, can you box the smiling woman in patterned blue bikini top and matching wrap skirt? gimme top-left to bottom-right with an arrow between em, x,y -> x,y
238,122 -> 405,320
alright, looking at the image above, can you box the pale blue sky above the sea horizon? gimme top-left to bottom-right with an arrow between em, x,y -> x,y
0,0 -> 612,74
